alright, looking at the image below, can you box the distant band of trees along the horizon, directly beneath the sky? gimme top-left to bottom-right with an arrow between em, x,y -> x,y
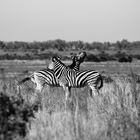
0,39 -> 140,51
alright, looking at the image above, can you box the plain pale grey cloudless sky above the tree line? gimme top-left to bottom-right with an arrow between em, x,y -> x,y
0,0 -> 140,42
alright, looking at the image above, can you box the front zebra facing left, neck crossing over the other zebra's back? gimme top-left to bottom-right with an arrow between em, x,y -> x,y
49,57 -> 103,101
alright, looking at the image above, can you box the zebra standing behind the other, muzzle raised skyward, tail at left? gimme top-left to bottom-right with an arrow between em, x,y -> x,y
19,52 -> 86,92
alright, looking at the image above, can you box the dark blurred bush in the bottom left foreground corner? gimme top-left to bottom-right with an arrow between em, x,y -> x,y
0,93 -> 34,140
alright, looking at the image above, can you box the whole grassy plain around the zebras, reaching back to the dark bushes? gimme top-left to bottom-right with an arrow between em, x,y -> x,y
0,61 -> 140,140
